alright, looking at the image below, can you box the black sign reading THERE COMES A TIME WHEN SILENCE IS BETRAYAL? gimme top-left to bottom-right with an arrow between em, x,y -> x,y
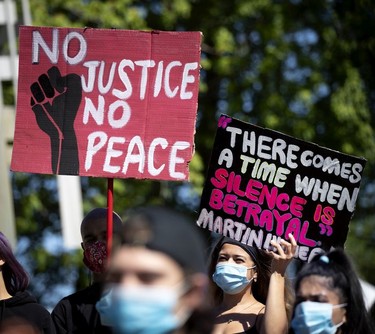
197,115 -> 366,261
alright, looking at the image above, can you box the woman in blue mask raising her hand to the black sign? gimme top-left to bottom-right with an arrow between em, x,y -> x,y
209,235 -> 296,334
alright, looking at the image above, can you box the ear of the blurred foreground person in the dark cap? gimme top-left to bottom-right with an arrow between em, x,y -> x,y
180,273 -> 208,310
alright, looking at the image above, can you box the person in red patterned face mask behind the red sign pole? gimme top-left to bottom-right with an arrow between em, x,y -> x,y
52,208 -> 122,334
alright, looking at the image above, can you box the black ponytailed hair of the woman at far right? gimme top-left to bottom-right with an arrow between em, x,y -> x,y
295,248 -> 371,334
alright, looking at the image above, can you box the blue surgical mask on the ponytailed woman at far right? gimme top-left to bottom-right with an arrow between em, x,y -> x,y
291,301 -> 346,334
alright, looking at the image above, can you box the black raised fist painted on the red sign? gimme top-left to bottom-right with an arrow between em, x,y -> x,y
30,66 -> 82,175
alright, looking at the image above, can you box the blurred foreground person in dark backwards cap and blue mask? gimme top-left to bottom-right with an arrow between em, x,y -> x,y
97,207 -> 214,334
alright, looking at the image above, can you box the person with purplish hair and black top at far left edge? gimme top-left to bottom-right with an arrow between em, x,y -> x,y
0,232 -> 55,334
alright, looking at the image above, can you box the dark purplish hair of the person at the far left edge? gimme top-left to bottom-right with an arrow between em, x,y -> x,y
0,232 -> 29,296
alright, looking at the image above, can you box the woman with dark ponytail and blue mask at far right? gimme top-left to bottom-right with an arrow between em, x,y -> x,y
291,249 -> 375,334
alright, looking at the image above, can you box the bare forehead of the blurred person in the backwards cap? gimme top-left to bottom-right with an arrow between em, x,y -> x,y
109,246 -> 183,277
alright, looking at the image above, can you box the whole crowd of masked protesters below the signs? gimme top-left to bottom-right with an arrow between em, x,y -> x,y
0,206 -> 375,334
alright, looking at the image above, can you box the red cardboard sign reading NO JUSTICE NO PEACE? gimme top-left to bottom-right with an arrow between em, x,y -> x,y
11,26 -> 201,180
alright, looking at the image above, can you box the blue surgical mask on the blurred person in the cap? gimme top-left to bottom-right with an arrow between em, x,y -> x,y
96,286 -> 186,334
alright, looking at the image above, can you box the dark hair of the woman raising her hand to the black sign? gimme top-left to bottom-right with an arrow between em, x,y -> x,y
208,236 -> 272,305
